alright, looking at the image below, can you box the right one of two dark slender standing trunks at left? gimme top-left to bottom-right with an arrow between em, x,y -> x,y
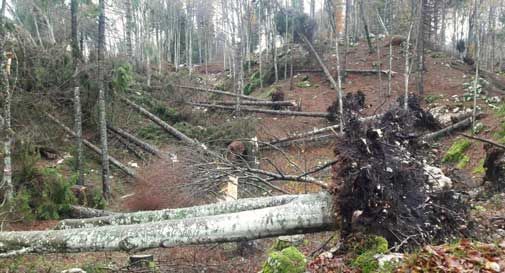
98,0 -> 112,199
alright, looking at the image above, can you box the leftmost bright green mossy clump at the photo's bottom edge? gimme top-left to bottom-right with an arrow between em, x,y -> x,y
262,246 -> 307,273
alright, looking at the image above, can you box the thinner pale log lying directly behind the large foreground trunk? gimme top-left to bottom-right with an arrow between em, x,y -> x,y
55,192 -> 299,229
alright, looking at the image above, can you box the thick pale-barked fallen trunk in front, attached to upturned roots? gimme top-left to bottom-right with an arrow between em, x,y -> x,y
0,193 -> 337,255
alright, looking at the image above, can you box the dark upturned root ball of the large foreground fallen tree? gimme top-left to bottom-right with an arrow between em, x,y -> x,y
333,96 -> 469,249
